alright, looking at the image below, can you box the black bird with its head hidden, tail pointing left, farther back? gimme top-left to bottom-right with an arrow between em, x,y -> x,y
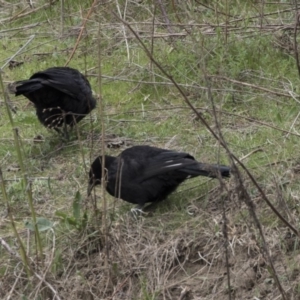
9,67 -> 96,134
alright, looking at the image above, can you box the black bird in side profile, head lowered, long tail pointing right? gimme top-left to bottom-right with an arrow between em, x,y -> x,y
88,146 -> 230,210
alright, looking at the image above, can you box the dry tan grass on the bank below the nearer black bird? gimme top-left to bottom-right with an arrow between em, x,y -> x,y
1,184 -> 299,299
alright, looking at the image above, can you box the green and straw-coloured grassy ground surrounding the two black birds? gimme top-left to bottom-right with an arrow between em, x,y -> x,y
0,0 -> 299,299
